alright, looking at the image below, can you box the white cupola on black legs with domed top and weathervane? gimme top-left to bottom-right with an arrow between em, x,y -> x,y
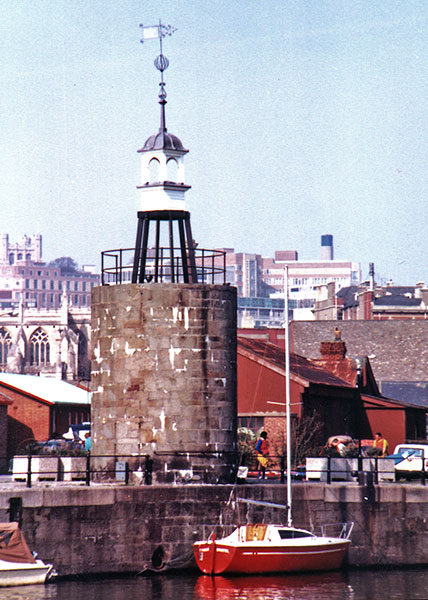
132,23 -> 198,283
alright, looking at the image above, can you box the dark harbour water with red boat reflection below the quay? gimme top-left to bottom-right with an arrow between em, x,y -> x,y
0,568 -> 428,600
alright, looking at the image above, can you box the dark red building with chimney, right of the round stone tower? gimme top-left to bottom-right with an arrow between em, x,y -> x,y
238,332 -> 427,446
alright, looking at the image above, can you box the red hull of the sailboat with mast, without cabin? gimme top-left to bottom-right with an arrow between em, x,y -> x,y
193,524 -> 350,575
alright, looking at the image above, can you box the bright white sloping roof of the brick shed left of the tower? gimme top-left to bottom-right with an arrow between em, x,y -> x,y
0,373 -> 91,404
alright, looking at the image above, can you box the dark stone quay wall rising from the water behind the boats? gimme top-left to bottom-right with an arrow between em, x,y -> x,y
0,482 -> 428,576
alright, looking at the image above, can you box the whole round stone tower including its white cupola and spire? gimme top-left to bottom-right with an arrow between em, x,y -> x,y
92,25 -> 237,483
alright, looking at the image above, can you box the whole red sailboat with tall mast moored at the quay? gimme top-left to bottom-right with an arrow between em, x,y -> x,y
193,269 -> 353,575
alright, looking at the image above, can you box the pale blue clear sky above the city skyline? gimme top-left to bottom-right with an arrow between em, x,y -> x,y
0,0 -> 428,285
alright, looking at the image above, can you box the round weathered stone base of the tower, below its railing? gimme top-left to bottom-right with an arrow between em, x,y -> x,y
92,283 -> 236,483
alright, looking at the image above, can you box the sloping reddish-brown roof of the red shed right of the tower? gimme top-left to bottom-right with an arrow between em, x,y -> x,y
238,336 -> 352,388
